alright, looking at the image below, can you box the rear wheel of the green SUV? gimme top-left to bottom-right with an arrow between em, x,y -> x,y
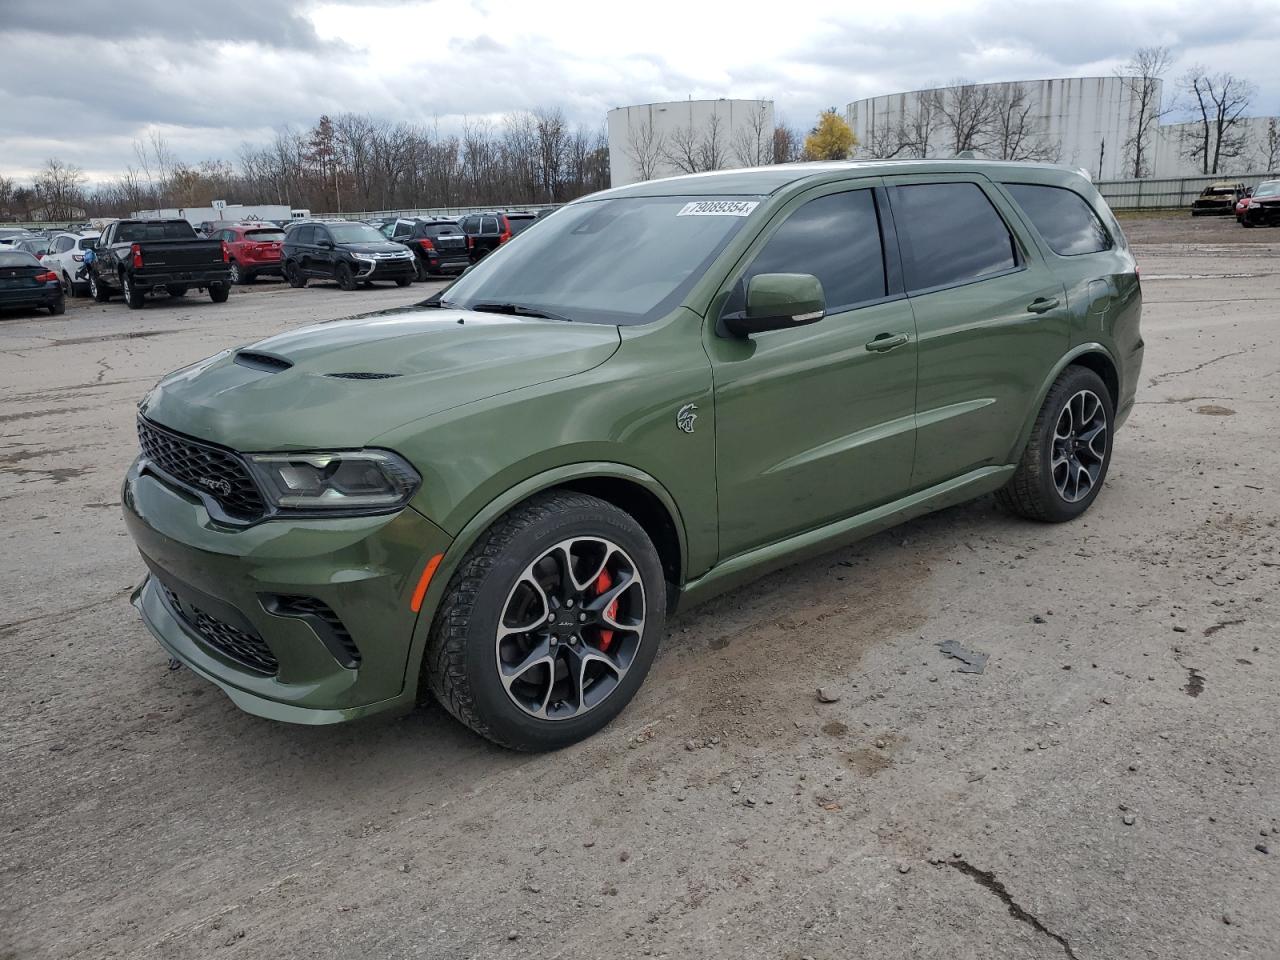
996,366 -> 1115,524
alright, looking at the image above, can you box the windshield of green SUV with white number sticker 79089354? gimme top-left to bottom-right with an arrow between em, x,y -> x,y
440,197 -> 756,324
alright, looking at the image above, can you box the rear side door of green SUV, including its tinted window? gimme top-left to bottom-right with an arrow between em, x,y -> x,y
887,175 -> 1070,490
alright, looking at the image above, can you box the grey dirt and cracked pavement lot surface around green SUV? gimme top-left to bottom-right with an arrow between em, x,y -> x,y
0,218 -> 1280,960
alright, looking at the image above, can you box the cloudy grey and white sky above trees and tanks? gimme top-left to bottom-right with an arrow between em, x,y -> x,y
0,0 -> 1280,180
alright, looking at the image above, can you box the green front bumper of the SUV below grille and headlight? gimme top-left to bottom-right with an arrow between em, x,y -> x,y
122,462 -> 449,723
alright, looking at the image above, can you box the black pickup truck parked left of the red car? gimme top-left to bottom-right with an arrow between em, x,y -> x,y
88,220 -> 232,310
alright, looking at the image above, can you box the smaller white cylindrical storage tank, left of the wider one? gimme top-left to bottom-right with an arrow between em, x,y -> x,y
608,100 -> 773,187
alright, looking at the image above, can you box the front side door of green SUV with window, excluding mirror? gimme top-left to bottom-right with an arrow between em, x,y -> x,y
707,180 -> 915,561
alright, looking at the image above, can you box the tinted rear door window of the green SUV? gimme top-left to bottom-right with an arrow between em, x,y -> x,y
892,183 -> 1018,292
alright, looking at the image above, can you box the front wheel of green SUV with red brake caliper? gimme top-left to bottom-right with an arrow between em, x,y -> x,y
422,490 -> 667,751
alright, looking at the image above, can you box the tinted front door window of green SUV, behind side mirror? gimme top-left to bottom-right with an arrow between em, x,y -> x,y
730,189 -> 886,314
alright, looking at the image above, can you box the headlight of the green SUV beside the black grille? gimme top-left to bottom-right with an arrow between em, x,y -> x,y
248,451 -> 422,512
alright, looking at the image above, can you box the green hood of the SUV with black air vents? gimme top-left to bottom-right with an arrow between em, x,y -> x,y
141,308 -> 621,452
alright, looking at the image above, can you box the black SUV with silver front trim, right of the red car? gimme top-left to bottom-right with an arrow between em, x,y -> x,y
283,221 -> 417,291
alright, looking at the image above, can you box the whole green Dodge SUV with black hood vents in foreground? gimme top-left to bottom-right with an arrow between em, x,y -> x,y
123,161 -> 1143,750
